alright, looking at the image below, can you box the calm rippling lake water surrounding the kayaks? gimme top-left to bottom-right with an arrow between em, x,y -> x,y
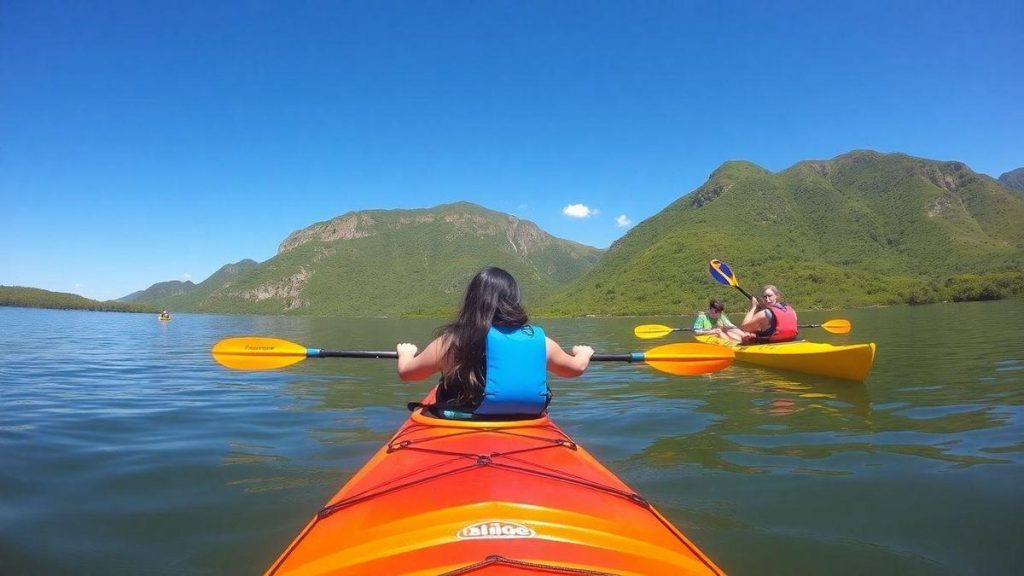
0,300 -> 1024,575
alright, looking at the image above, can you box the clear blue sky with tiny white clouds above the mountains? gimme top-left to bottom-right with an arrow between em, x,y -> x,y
0,0 -> 1024,299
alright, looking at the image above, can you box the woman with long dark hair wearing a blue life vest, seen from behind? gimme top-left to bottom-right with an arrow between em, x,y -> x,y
396,266 -> 594,417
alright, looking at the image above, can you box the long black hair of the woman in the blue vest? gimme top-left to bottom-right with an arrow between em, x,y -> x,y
437,266 -> 529,406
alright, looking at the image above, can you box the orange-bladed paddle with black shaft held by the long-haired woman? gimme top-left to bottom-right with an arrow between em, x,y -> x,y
210,336 -> 735,376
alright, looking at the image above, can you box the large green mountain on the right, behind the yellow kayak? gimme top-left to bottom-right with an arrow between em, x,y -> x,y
541,151 -> 1024,315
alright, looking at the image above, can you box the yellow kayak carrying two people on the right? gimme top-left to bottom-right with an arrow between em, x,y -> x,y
693,334 -> 874,381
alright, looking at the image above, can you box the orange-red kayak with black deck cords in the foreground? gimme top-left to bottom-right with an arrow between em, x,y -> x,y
266,385 -> 723,576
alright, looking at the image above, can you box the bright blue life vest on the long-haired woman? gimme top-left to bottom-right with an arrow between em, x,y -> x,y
473,325 -> 549,415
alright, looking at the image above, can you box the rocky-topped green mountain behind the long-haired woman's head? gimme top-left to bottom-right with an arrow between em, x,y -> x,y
130,202 -> 602,316
